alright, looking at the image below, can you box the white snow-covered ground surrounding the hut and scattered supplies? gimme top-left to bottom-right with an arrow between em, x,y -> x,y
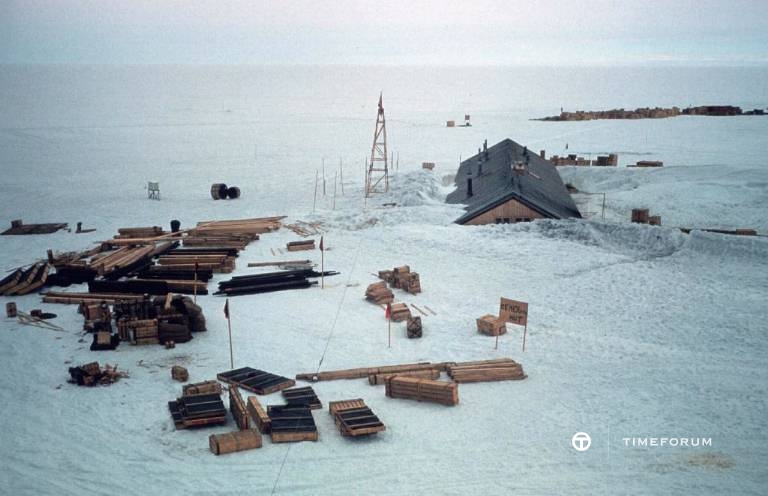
0,69 -> 768,495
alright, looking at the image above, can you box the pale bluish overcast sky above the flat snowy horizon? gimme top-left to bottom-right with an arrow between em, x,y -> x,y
0,0 -> 768,65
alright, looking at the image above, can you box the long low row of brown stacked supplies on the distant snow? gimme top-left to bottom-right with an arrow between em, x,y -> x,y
534,105 -> 765,121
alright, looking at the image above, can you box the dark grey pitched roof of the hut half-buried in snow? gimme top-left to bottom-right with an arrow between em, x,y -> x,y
446,139 -> 581,224
